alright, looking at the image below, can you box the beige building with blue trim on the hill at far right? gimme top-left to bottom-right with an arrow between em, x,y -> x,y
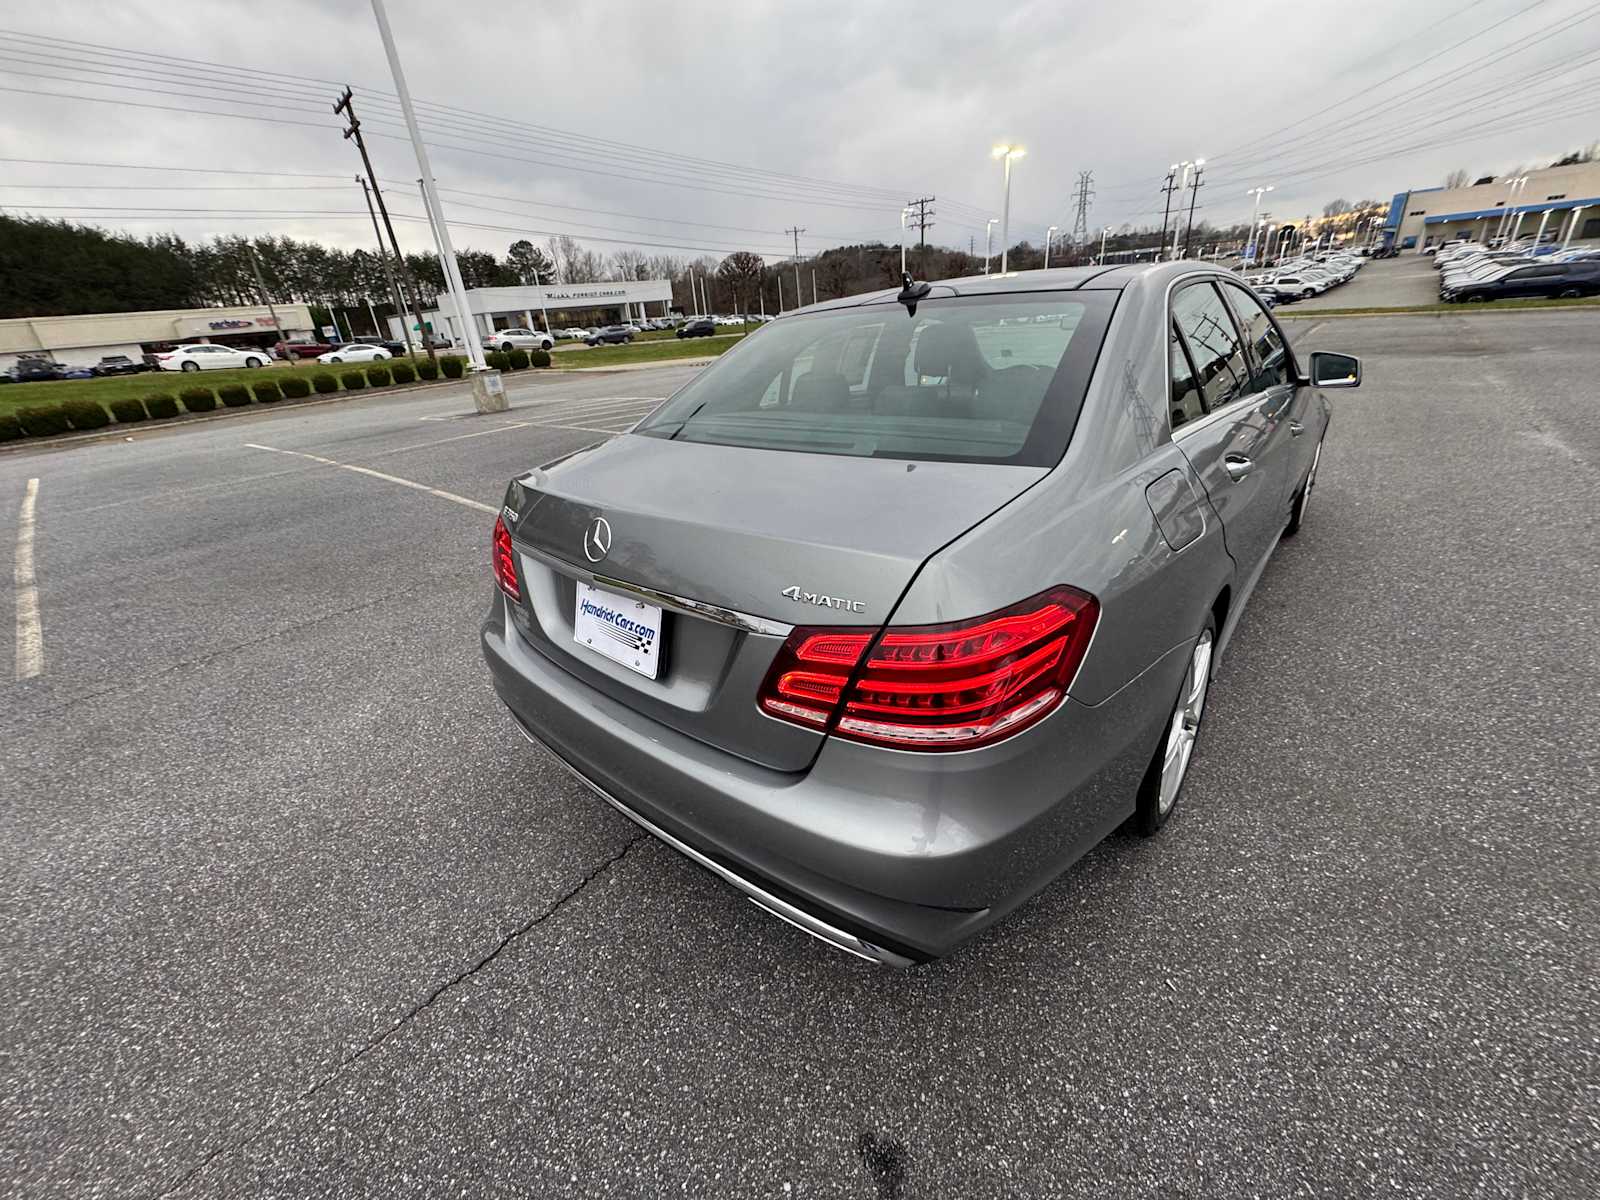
1382,162 -> 1600,251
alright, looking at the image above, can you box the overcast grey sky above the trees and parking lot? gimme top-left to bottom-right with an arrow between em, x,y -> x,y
0,0 -> 1600,265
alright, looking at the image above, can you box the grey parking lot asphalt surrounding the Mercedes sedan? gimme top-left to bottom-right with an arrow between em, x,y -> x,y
0,315 -> 1600,1200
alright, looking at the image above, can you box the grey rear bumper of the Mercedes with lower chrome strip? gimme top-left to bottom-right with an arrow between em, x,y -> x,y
482,597 -> 1187,966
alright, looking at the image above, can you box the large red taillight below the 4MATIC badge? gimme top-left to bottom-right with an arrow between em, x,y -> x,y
760,587 -> 1099,750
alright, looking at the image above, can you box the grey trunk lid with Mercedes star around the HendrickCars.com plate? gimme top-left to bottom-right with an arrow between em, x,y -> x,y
504,437 -> 1046,771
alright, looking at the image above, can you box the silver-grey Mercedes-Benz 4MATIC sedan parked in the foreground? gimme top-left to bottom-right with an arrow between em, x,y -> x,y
483,262 -> 1360,965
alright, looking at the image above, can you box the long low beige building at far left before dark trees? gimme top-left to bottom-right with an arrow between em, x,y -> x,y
0,304 -> 315,371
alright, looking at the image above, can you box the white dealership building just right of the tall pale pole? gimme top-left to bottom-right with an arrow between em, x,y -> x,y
389,278 -> 672,346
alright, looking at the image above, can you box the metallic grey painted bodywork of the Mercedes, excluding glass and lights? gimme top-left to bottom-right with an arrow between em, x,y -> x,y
483,264 -> 1350,963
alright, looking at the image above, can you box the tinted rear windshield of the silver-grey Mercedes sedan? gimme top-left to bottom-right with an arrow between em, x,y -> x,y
635,291 -> 1115,466
